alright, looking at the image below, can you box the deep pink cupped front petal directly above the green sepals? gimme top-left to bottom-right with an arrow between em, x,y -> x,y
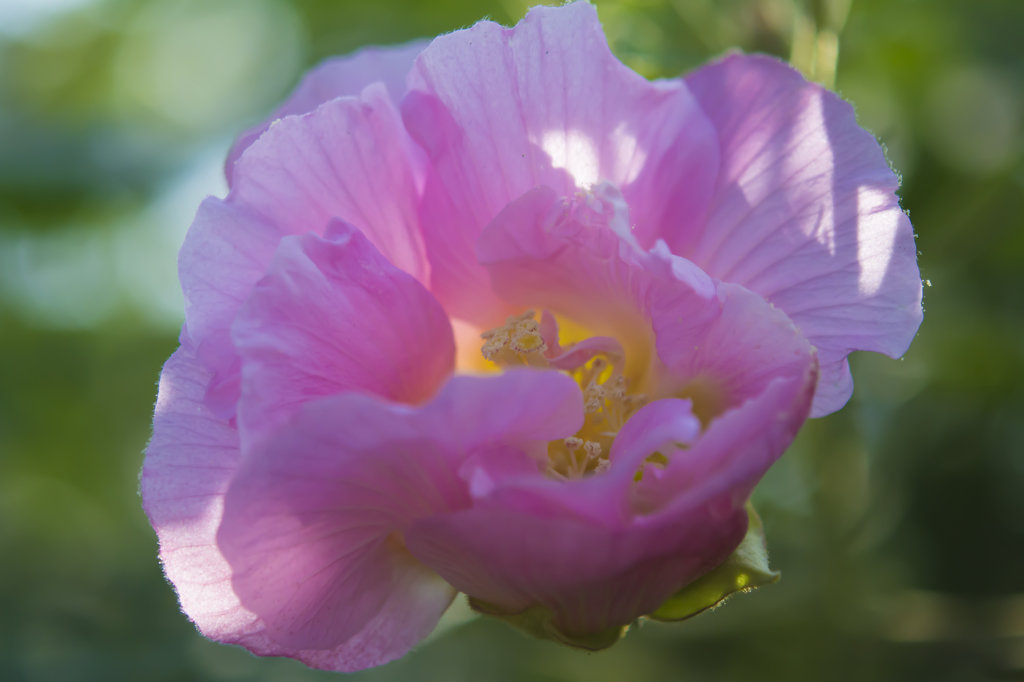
406,346 -> 817,635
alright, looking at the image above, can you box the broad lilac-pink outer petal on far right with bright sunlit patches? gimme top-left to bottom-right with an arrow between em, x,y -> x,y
675,54 -> 922,416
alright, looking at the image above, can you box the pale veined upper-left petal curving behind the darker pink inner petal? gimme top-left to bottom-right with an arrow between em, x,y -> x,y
178,85 -> 427,417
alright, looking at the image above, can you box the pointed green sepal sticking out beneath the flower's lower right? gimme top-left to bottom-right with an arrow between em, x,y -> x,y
648,503 -> 781,622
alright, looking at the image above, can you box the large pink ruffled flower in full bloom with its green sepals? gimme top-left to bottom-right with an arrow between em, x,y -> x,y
141,2 -> 922,671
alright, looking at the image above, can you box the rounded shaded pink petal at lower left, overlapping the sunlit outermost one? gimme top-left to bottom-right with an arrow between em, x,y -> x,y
217,393 -> 465,649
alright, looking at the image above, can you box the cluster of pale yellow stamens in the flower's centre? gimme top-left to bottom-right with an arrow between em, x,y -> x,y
480,310 -> 647,480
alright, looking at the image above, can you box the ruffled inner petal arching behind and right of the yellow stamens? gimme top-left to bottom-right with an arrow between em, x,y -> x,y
477,186 -> 814,413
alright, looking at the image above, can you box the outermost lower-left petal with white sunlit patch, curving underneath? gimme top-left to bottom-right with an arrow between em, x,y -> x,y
140,334 -> 473,671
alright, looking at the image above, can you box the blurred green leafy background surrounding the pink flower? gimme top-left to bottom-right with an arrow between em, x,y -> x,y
0,0 -> 1024,682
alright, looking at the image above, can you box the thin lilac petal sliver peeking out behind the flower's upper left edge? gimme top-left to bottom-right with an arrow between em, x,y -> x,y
224,40 -> 428,184
